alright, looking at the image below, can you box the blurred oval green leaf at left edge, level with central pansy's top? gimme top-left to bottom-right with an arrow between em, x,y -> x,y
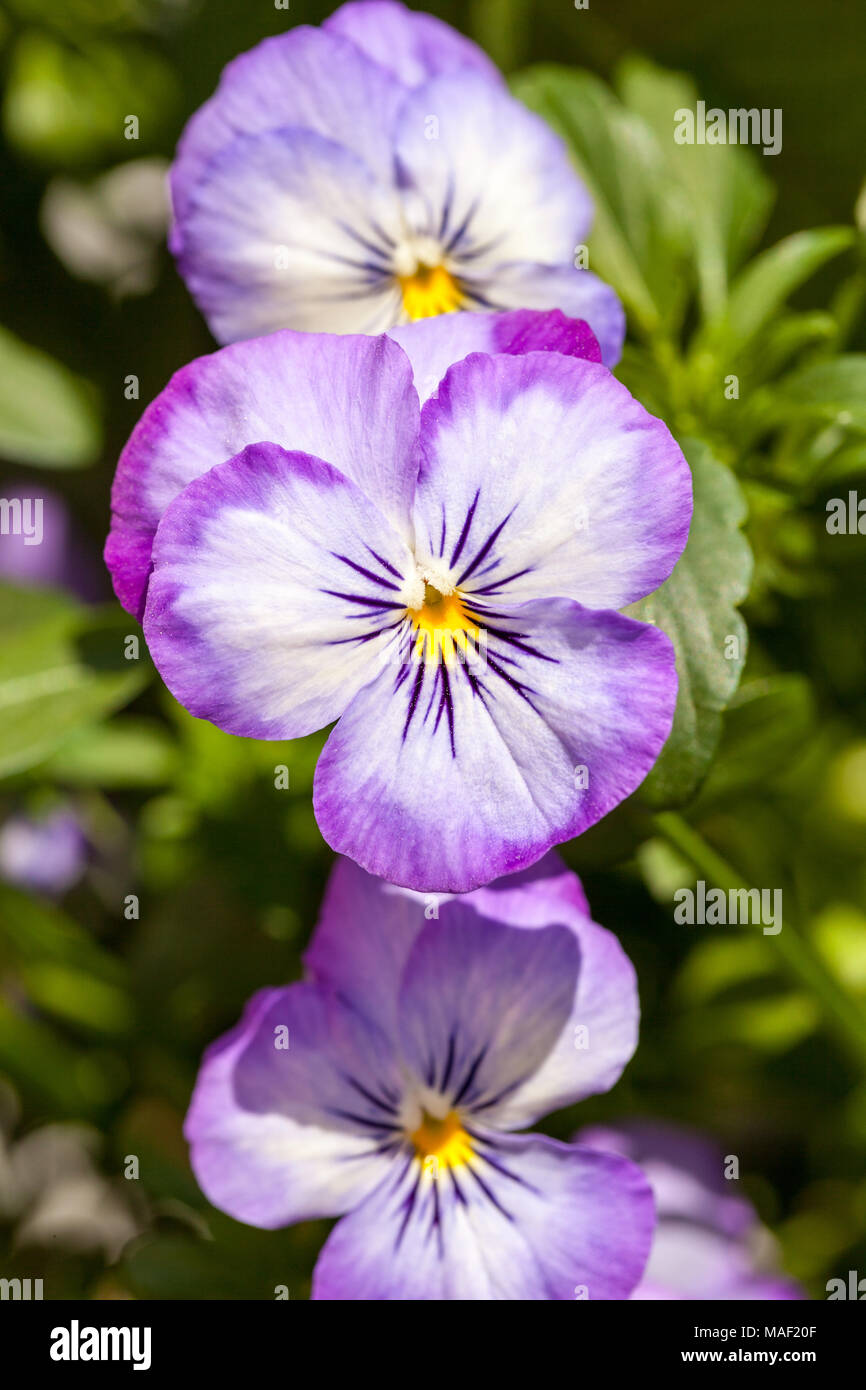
0,328 -> 101,468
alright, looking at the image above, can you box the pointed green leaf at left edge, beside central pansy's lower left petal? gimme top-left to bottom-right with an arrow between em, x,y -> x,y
0,585 -> 149,777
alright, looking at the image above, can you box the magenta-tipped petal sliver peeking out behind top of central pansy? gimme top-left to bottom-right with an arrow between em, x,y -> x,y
388,309 -> 602,403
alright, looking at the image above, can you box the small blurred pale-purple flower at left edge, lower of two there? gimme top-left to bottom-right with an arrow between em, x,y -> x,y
0,806 -> 88,898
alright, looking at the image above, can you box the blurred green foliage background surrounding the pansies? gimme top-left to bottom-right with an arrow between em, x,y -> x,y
0,0 -> 866,1298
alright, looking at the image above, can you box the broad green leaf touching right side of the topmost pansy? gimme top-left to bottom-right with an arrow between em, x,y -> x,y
513,64 -> 688,334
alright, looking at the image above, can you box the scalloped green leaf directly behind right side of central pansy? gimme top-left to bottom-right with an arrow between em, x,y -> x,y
630,439 -> 752,808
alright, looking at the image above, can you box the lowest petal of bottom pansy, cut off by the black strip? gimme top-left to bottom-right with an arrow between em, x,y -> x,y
313,1134 -> 653,1301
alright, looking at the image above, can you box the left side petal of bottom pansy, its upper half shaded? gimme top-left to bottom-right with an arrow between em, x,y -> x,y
185,986 -> 393,1229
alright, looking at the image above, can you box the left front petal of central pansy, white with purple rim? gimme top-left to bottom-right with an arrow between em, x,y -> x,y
143,443 -> 411,738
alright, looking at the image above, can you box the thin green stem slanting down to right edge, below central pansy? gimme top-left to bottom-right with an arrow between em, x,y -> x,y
653,810 -> 866,1063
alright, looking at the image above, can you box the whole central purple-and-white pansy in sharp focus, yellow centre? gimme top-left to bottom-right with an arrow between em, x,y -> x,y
106,313 -> 691,892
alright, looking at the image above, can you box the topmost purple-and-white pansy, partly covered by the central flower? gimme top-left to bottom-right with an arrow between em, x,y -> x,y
171,0 -> 624,364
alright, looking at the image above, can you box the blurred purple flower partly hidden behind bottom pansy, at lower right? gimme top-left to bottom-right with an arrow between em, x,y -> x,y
575,1120 -> 806,1301
